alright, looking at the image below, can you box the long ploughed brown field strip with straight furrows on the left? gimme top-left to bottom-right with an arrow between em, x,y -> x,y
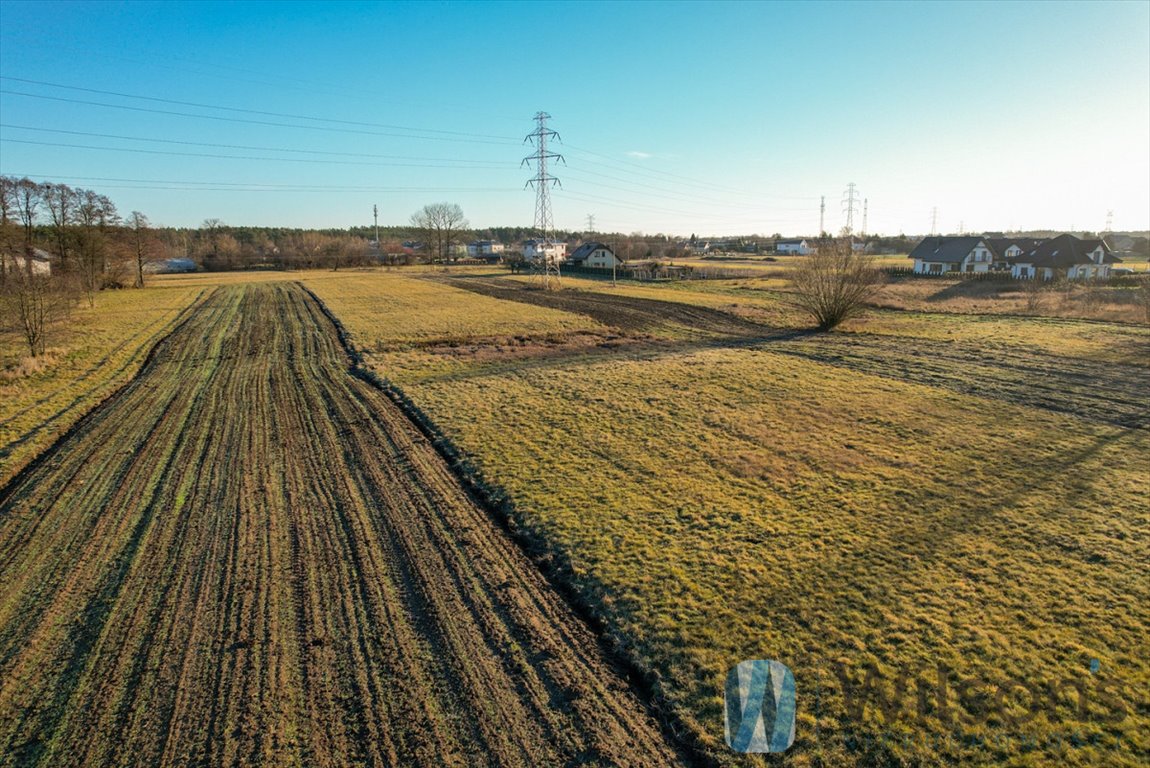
0,284 -> 681,766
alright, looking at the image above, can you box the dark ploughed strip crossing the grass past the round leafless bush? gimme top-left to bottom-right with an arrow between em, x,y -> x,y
432,278 -> 1150,427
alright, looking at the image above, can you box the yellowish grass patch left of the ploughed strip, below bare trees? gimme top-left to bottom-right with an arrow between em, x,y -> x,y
0,283 -> 205,485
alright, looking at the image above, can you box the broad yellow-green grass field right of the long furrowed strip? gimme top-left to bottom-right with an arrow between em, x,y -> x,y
313,270 -> 1150,766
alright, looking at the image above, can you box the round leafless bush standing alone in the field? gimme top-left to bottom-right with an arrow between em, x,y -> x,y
791,238 -> 882,330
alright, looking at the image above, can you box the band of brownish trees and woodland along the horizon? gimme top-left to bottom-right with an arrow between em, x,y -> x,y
0,176 -> 1150,275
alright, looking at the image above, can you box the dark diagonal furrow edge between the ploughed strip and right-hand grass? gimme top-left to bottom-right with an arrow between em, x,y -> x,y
297,282 -> 720,768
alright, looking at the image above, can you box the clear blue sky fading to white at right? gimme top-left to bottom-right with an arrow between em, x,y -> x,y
0,0 -> 1150,235
